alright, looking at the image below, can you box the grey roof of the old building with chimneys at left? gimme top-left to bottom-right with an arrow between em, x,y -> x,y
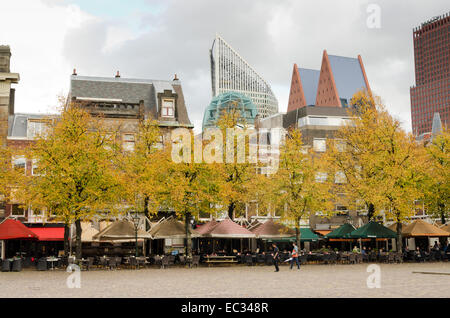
70,75 -> 191,125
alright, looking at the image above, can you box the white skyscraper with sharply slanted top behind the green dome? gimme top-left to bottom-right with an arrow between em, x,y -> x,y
210,35 -> 278,118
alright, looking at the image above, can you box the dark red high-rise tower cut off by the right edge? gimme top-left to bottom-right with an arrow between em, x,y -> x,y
410,12 -> 450,136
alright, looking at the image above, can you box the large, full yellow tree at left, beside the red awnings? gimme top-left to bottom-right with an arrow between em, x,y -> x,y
21,103 -> 121,259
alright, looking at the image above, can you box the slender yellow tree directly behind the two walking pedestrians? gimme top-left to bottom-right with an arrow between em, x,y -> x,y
267,129 -> 333,246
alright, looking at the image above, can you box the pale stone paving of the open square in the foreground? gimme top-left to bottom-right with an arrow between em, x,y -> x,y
0,262 -> 450,298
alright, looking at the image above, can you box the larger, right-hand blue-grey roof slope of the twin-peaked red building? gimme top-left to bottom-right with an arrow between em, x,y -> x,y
328,55 -> 368,104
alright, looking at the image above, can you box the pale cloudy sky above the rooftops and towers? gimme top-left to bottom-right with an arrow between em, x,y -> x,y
0,0 -> 450,131
